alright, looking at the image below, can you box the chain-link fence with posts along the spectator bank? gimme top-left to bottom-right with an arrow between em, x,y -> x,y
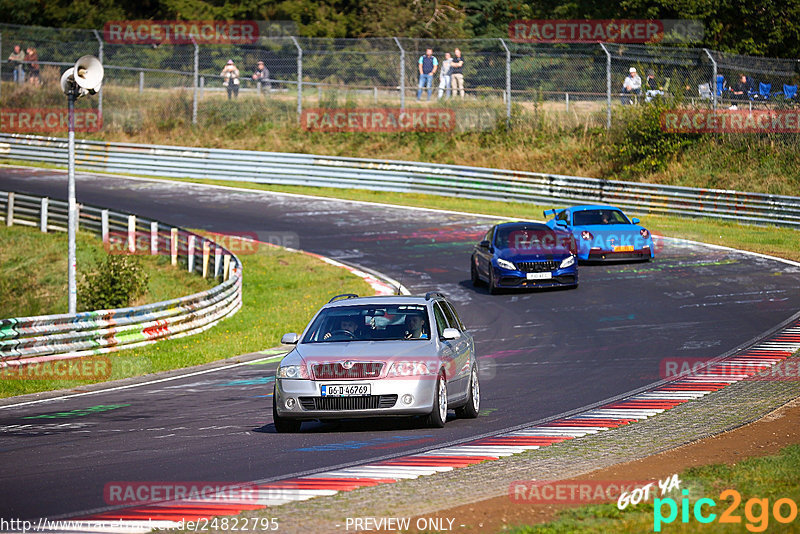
0,24 -> 800,139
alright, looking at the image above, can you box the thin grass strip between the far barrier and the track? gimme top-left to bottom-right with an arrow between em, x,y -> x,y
164,178 -> 800,261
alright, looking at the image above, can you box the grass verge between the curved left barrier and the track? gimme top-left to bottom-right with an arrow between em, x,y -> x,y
0,237 -> 373,397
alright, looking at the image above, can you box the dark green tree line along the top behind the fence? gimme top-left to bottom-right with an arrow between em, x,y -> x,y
0,0 -> 800,58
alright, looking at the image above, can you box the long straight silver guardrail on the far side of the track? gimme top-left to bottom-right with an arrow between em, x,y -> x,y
0,134 -> 800,228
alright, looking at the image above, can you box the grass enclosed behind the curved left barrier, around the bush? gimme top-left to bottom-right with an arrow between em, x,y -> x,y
0,225 -> 214,318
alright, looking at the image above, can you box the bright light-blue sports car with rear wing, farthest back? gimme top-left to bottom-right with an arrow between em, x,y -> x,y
544,205 -> 655,261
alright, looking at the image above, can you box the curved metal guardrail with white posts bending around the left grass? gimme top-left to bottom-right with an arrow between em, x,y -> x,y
0,191 -> 242,368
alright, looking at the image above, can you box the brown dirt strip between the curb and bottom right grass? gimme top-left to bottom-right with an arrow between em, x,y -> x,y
411,398 -> 800,534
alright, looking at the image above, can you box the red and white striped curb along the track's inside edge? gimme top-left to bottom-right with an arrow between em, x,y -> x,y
64,320 -> 800,533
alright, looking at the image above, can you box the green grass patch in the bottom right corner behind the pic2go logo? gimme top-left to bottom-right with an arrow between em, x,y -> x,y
503,445 -> 800,534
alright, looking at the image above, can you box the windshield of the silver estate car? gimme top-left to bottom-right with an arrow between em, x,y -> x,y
303,304 -> 431,343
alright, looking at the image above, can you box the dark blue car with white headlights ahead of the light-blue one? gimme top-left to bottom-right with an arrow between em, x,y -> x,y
470,222 -> 578,294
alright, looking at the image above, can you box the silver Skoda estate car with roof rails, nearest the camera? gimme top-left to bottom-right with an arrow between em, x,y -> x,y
272,293 -> 480,432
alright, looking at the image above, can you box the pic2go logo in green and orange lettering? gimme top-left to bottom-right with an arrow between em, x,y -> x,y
653,489 -> 797,532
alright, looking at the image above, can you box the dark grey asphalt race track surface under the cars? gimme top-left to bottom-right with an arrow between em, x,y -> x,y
0,168 -> 800,519
